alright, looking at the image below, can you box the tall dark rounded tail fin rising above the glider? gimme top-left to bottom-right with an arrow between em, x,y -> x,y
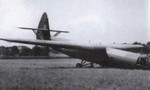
36,12 -> 51,40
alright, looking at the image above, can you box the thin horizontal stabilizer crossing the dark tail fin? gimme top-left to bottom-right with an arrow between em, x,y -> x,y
18,27 -> 69,33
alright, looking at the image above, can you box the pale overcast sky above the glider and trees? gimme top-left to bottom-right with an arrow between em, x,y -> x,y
0,0 -> 150,45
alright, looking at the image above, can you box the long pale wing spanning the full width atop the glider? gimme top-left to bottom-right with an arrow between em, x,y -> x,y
0,38 -> 143,50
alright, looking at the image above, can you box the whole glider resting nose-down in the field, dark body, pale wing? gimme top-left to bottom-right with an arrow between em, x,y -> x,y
0,13 -> 150,69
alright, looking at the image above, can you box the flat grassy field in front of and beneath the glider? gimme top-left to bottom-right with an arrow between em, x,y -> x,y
0,59 -> 150,90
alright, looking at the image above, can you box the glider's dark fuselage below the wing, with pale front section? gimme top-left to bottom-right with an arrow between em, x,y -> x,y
54,48 -> 150,69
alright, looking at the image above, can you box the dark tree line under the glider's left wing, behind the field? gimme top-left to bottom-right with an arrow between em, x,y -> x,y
0,46 -> 53,56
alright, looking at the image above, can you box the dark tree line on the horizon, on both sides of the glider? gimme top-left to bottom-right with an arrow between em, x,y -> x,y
0,42 -> 150,56
